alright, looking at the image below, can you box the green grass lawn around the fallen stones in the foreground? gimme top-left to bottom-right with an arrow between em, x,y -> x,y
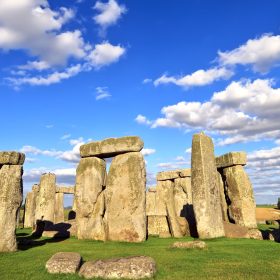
0,228 -> 280,280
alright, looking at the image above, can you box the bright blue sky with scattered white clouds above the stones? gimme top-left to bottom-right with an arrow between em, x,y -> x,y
0,0 -> 280,206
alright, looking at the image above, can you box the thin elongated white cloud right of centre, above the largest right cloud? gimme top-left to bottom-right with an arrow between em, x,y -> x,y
154,67 -> 233,88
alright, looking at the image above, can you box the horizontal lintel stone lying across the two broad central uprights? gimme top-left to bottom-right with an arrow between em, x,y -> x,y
80,136 -> 144,158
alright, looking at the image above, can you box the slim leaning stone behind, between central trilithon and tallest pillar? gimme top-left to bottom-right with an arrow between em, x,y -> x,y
157,180 -> 183,237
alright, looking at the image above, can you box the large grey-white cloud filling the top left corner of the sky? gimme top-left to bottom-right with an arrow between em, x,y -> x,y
0,0 -> 85,65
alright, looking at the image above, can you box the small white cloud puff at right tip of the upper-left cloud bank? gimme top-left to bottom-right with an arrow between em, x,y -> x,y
88,42 -> 125,69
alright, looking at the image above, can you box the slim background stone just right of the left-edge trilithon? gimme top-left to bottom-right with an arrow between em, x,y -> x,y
24,185 -> 39,228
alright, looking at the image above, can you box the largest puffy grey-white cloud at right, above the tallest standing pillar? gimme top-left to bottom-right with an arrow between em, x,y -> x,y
136,79 -> 280,145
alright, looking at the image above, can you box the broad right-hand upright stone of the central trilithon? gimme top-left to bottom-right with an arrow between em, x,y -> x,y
105,152 -> 146,242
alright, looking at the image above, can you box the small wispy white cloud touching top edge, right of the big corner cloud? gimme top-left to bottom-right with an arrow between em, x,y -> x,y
93,0 -> 127,33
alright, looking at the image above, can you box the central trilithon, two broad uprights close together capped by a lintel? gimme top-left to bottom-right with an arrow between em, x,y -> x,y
75,136 -> 146,242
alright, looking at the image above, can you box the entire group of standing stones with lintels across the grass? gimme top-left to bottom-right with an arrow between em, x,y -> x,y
0,133 -> 258,252
